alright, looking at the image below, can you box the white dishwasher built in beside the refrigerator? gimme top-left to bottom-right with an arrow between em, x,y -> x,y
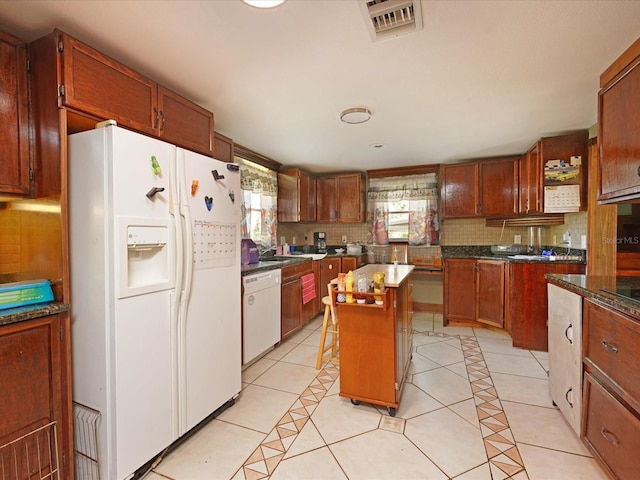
242,269 -> 282,365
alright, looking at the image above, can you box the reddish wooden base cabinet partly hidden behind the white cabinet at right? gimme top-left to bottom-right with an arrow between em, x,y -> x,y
507,262 -> 585,352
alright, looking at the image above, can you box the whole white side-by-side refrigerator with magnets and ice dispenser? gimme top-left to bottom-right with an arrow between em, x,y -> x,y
68,126 -> 241,480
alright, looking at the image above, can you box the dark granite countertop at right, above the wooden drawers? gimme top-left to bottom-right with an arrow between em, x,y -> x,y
545,273 -> 640,320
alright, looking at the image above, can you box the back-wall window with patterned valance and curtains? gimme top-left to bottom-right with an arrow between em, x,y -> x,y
367,173 -> 440,245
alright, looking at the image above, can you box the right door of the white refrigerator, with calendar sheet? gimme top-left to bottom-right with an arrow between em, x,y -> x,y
177,149 -> 241,435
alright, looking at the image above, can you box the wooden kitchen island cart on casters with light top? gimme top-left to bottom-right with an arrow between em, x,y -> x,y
332,264 -> 414,417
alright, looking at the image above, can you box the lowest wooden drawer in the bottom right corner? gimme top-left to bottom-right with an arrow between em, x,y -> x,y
584,373 -> 640,480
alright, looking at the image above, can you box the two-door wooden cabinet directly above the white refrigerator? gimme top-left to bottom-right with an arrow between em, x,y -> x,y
54,30 -> 214,156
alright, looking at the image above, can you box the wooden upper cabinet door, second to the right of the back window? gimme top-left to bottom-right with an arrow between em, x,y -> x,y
477,157 -> 519,217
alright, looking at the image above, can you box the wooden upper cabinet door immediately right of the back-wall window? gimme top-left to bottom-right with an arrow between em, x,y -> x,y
440,162 -> 478,218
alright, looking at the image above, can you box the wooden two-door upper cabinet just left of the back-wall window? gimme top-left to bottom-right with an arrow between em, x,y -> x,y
316,173 -> 366,222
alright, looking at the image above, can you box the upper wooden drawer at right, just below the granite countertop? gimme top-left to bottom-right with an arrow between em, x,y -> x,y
584,301 -> 640,399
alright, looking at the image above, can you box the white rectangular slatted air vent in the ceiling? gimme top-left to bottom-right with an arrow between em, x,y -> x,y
360,0 -> 422,41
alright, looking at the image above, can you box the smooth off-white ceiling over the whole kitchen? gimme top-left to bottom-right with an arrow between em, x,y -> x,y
0,0 -> 640,173
